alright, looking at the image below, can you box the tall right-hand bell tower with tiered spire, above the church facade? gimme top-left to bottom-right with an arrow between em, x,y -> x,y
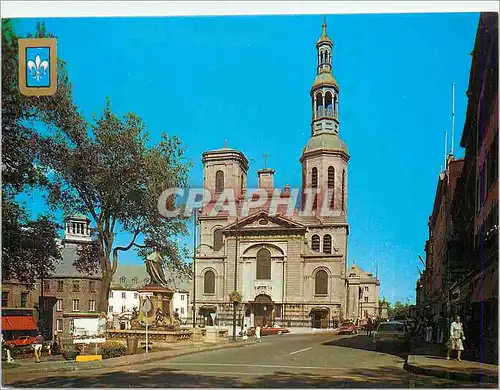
300,20 -> 349,218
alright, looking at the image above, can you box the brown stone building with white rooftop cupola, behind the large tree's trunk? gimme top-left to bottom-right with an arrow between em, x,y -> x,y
43,216 -> 101,340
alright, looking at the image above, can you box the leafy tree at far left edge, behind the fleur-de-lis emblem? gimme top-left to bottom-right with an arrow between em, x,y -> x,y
2,19 -> 80,284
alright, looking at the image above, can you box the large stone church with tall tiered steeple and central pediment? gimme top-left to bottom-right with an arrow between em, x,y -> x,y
195,23 -> 378,328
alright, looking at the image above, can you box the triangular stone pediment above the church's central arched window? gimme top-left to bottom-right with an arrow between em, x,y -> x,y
224,211 -> 306,232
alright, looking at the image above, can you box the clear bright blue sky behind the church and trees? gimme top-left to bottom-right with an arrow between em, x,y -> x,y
15,13 -> 479,302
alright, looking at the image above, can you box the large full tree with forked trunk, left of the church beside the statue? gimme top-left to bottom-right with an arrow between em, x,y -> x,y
40,100 -> 190,310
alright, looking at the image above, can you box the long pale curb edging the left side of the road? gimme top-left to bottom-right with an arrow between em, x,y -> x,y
3,342 -> 246,374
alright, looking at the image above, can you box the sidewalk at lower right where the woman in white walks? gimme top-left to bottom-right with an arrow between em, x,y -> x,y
404,341 -> 498,383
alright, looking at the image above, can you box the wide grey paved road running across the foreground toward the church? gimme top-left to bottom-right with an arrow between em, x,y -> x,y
4,333 -> 496,388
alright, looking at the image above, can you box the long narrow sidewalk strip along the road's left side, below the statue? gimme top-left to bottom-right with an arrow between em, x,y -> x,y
3,341 -> 250,374
